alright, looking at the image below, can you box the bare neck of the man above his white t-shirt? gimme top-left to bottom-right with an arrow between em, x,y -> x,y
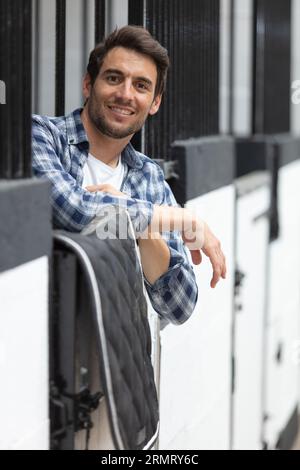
81,107 -> 131,168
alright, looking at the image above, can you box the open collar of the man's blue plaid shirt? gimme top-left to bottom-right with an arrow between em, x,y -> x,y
66,108 -> 143,169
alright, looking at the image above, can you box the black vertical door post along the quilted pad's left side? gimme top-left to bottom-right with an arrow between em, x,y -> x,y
49,249 -> 77,450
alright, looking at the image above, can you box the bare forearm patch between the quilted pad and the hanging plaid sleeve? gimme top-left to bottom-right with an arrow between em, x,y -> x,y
139,233 -> 171,284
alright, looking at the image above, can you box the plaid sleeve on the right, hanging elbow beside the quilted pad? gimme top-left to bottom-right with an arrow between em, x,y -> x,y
145,169 -> 198,325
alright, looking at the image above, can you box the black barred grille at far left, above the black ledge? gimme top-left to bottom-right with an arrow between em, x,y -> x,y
0,0 -> 31,179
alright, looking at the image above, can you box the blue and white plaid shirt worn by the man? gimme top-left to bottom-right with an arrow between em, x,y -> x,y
32,109 -> 198,324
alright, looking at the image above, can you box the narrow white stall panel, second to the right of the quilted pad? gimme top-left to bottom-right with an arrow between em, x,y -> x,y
233,186 -> 270,450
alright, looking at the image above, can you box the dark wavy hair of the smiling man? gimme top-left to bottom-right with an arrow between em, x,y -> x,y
87,25 -> 170,97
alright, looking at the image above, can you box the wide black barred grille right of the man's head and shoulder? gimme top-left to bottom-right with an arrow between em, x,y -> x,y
129,0 -> 220,159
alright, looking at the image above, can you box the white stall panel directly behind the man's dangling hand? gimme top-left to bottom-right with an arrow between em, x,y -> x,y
159,186 -> 234,449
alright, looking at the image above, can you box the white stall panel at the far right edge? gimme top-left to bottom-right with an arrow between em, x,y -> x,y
265,161 -> 300,447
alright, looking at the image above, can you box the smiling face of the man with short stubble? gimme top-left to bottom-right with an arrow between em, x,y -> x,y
83,47 -> 161,139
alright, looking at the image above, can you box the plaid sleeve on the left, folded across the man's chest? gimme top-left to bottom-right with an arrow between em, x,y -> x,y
32,117 -> 153,232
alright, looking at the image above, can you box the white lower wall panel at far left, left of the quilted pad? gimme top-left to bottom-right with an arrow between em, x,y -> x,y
0,257 -> 49,449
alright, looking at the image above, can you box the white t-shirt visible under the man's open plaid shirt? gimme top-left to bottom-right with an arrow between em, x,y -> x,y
82,153 -> 125,191
